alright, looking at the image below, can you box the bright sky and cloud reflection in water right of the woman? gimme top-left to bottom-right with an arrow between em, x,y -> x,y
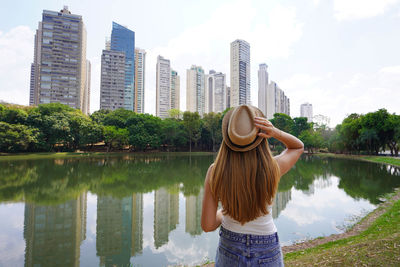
275,176 -> 374,245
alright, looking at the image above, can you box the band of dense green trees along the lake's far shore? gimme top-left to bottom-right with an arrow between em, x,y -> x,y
0,103 -> 400,155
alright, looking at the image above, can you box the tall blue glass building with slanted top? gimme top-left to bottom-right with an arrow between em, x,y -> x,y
111,22 -> 135,110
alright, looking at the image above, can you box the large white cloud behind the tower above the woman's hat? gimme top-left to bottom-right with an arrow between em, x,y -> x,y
145,0 -> 302,113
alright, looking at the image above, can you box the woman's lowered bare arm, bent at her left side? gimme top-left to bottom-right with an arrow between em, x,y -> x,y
201,165 -> 222,232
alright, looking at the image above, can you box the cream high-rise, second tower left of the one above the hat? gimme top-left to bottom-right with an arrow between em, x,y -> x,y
186,65 -> 205,116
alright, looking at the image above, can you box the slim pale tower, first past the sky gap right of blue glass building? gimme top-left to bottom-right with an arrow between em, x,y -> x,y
156,56 -> 171,118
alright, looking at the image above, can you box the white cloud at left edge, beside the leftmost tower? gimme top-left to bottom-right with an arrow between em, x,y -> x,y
0,26 -> 34,105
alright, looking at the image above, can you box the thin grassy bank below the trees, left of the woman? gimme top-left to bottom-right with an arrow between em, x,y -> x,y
0,152 -> 214,161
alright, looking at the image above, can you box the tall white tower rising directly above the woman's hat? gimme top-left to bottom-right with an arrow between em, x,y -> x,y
230,40 -> 250,107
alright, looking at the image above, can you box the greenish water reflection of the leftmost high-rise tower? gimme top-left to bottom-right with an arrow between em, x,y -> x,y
24,193 -> 87,266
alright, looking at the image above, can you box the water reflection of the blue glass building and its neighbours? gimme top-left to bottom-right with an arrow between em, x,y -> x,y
96,194 -> 143,266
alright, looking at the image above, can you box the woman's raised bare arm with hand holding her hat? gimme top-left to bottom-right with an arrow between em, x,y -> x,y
254,117 -> 304,175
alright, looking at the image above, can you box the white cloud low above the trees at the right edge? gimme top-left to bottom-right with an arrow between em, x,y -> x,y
278,65 -> 400,127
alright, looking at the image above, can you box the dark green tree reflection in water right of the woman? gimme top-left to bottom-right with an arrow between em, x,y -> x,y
279,156 -> 400,204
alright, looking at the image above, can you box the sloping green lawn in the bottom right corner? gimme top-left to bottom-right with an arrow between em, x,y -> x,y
285,200 -> 400,266
